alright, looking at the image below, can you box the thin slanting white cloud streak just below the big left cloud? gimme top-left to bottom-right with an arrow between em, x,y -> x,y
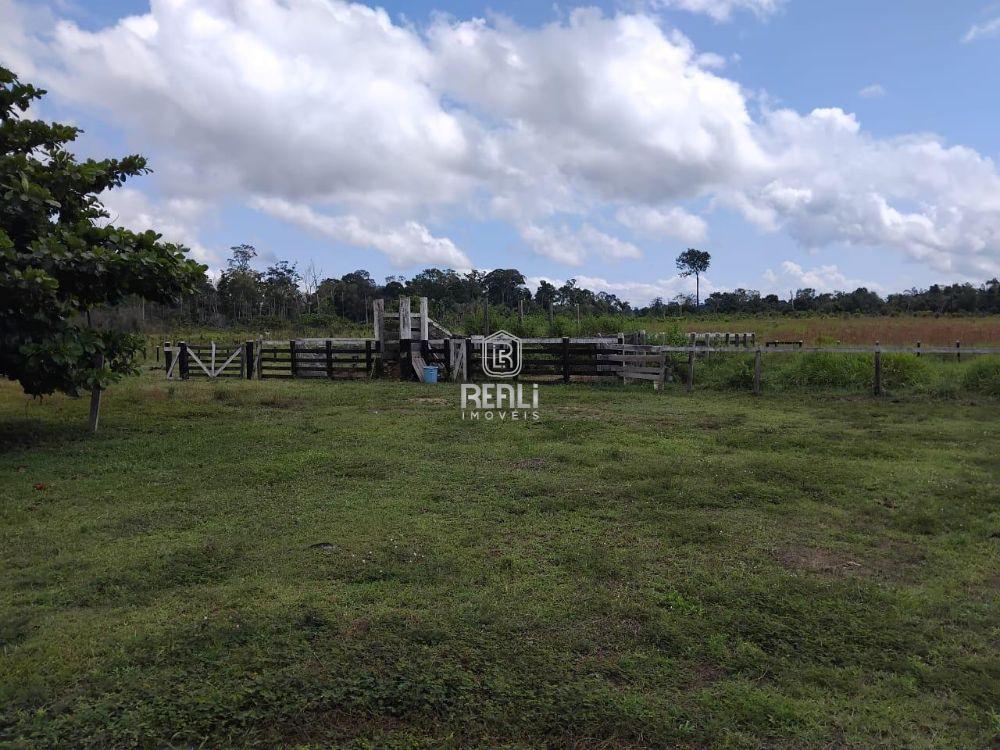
251,198 -> 472,268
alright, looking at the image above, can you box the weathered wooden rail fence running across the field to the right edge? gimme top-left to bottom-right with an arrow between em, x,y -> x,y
163,334 -> 1000,394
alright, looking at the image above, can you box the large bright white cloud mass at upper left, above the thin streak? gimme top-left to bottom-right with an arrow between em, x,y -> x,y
37,0 -> 470,208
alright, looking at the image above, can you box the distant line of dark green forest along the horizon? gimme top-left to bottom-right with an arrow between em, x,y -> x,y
132,245 -> 1000,328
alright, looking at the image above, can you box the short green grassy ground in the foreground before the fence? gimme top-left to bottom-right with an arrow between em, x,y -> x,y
0,375 -> 1000,748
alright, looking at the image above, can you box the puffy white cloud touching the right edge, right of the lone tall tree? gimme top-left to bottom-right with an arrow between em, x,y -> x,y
722,109 -> 1000,277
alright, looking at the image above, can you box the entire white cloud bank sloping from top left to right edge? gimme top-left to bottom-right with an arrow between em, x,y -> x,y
0,0 -> 1000,278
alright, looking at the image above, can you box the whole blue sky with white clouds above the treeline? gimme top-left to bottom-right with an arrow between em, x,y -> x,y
0,0 -> 1000,304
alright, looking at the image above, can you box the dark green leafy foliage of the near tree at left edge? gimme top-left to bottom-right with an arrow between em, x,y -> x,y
0,68 -> 205,396
